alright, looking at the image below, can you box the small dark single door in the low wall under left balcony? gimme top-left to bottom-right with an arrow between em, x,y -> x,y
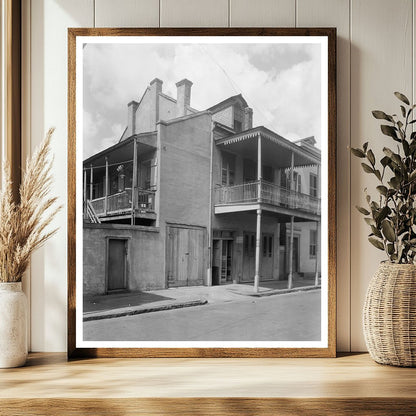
107,238 -> 127,291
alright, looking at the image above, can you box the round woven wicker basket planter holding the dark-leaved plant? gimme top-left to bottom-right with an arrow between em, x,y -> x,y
363,262 -> 416,367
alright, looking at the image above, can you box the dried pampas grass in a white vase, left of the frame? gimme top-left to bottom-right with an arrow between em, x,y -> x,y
0,129 -> 61,368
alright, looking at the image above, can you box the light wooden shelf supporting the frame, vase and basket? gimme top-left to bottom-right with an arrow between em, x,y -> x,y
0,353 -> 416,416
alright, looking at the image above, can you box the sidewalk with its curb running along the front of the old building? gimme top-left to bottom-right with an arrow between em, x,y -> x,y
83,278 -> 320,322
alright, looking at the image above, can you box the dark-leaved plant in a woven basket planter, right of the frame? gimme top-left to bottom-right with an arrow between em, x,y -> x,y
351,92 -> 416,367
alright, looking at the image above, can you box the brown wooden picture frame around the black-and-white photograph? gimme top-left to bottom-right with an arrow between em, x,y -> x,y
68,28 -> 337,358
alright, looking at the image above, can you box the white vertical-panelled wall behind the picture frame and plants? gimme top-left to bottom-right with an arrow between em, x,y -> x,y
23,0 -> 416,351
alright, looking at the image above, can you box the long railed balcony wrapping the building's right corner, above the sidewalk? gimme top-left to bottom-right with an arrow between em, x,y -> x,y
214,180 -> 321,216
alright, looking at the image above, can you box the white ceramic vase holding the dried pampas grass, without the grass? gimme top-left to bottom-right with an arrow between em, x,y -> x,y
0,282 -> 27,368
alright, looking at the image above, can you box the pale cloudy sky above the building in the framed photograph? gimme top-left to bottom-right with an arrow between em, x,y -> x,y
83,43 -> 321,158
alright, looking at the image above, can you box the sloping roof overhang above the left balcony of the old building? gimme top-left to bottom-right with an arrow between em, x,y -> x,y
83,132 -> 157,167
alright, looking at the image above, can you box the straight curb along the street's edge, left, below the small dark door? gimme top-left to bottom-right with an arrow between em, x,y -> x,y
83,299 -> 208,322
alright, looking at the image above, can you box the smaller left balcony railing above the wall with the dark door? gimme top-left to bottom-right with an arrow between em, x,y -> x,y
89,188 -> 155,221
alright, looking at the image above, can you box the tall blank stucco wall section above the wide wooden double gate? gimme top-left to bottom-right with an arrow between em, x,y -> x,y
159,114 -> 211,227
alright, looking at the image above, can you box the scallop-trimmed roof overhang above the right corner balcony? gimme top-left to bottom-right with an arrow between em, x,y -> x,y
215,126 -> 321,168
